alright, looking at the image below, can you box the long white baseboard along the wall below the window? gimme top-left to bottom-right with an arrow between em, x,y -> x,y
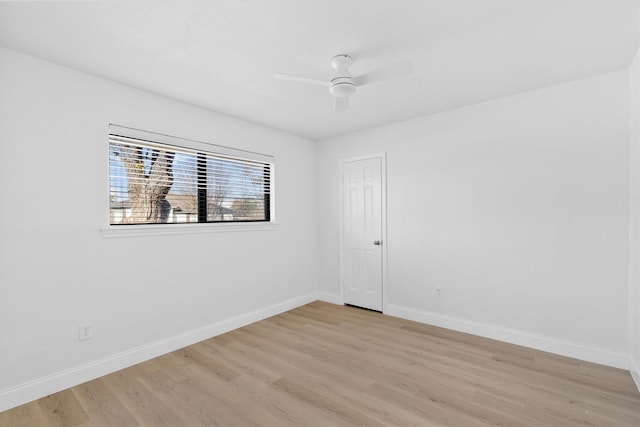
0,292 -> 319,412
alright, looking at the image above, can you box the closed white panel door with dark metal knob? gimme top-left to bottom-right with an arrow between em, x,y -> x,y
341,155 -> 385,311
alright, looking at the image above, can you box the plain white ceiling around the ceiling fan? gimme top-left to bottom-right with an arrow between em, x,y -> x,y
0,0 -> 639,140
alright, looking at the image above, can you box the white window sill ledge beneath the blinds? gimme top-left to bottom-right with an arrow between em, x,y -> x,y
100,222 -> 279,238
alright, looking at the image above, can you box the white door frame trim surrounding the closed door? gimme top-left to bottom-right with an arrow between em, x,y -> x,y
338,151 -> 387,313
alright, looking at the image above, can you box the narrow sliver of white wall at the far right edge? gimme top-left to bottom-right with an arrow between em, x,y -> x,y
628,46 -> 640,389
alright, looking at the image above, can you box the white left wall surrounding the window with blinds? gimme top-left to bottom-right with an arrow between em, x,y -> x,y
0,49 -> 317,411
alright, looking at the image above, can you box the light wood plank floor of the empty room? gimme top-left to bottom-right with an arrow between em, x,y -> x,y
0,302 -> 640,427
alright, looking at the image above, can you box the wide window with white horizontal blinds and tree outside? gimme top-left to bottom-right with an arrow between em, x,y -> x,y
109,125 -> 273,225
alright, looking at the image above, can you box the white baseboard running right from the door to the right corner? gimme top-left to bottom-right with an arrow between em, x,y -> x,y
385,304 -> 638,372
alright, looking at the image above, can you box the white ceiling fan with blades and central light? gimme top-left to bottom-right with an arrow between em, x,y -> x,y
274,54 -> 413,112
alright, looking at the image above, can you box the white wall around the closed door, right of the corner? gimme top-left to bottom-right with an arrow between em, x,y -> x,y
317,71 -> 629,367
